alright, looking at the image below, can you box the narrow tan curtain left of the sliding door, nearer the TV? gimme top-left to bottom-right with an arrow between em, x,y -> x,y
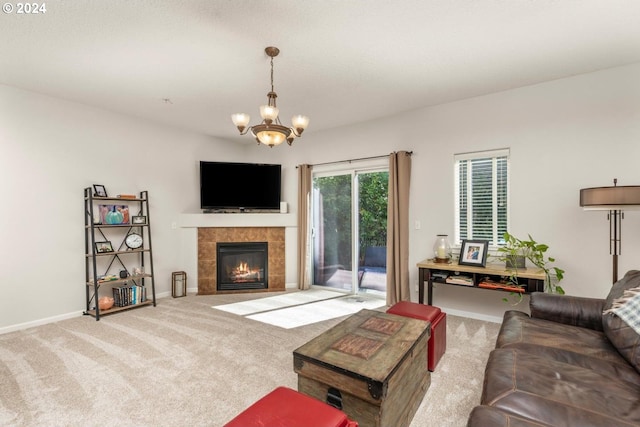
298,164 -> 311,289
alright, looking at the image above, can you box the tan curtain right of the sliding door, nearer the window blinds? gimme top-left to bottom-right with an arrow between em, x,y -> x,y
387,151 -> 411,305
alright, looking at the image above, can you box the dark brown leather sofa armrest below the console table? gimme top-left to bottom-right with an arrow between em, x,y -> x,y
529,292 -> 604,331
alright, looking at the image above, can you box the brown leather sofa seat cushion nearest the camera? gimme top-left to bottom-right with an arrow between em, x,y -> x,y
481,348 -> 640,427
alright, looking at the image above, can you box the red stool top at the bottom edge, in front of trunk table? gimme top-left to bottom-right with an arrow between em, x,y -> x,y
224,387 -> 358,427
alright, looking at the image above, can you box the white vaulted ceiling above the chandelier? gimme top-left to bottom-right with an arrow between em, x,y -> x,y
0,0 -> 640,142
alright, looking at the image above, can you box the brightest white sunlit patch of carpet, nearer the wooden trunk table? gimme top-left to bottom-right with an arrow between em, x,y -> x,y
247,291 -> 386,329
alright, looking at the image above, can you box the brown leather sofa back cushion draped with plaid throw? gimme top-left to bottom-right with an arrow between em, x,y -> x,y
602,270 -> 640,372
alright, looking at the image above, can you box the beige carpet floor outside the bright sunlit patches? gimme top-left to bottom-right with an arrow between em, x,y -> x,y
0,294 -> 499,427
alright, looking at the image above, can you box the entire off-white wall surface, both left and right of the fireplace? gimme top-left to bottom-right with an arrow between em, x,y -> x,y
0,64 -> 640,332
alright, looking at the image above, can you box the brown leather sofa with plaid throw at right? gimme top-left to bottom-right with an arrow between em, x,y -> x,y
467,271 -> 640,427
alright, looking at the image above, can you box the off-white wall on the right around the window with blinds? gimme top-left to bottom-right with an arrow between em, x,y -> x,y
288,64 -> 640,320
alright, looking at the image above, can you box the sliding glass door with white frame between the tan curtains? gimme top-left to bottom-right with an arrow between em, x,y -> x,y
311,159 -> 389,296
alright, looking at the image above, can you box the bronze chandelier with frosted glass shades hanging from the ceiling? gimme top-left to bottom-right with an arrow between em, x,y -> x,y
231,46 -> 309,147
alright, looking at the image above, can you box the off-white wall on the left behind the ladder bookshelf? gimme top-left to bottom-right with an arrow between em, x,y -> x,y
0,86 -> 245,332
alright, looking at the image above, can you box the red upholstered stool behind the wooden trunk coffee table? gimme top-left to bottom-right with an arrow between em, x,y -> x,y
387,301 -> 447,372
